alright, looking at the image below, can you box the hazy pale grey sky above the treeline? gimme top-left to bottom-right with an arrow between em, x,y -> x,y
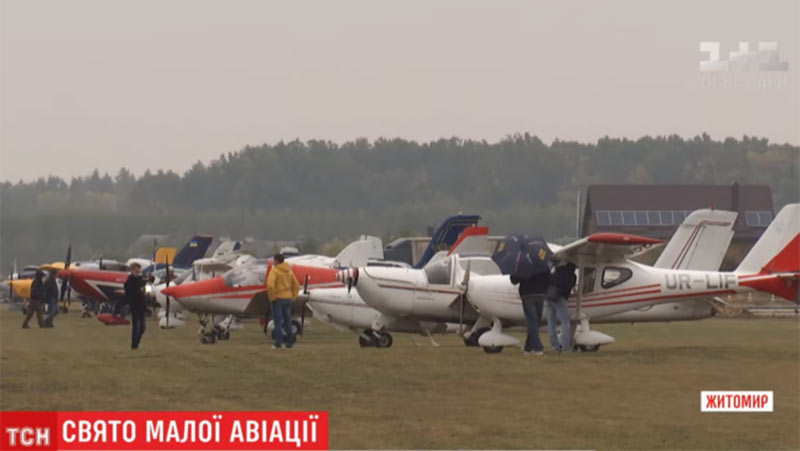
0,0 -> 800,180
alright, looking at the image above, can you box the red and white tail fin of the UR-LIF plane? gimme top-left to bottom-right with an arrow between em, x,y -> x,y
736,203 -> 800,303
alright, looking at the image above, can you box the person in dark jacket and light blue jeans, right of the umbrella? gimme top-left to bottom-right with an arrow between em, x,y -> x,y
545,263 -> 578,352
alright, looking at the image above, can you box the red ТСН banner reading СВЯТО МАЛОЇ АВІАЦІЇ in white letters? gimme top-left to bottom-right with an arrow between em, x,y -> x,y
0,412 -> 328,450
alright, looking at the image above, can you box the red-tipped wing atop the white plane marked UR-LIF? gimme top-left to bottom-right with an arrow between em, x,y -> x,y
553,233 -> 664,265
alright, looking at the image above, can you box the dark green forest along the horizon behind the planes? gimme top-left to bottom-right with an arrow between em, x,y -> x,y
0,134 -> 800,272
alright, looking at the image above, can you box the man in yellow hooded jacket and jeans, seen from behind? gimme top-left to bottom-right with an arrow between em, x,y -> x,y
267,254 -> 300,349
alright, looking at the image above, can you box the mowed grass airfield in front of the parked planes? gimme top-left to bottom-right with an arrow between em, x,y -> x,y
0,307 -> 800,449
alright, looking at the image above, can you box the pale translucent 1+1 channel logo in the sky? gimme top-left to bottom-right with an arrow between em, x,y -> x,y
700,41 -> 789,72
